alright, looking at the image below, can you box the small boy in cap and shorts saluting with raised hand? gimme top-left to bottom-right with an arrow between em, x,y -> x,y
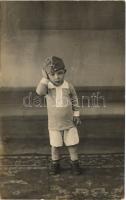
36,56 -> 81,175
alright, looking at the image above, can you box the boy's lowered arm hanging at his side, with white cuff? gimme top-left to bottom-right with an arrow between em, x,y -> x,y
69,84 -> 81,126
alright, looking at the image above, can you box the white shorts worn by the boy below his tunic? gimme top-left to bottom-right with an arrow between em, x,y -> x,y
49,127 -> 79,147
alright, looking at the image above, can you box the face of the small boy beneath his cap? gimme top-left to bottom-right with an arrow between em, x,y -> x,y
48,69 -> 66,86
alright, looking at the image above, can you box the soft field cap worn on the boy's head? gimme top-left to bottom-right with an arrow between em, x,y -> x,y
44,56 -> 65,73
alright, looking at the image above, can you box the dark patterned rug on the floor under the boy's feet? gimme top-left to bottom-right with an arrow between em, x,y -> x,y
0,154 -> 124,200
